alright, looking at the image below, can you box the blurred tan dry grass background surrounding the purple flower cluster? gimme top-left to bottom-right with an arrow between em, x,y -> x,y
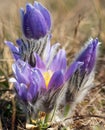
0,0 -> 105,130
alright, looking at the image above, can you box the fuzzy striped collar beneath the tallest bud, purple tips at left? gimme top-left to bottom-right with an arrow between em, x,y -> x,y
5,35 -> 50,67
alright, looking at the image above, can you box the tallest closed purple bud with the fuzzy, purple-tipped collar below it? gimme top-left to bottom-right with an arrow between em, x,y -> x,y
5,2 -> 51,64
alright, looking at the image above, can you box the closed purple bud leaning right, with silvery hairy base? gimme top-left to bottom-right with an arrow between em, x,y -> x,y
60,38 -> 99,105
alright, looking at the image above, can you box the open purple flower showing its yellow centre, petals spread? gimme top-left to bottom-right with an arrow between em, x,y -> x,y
35,38 -> 82,90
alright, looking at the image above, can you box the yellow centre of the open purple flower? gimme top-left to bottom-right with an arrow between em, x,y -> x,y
43,70 -> 53,88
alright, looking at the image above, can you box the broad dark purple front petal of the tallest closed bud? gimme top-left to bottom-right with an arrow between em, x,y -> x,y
23,4 -> 47,39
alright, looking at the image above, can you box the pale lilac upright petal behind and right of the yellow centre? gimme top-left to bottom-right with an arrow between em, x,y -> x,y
50,49 -> 66,72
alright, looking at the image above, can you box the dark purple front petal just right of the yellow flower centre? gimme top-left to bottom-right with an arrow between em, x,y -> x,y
48,71 -> 64,89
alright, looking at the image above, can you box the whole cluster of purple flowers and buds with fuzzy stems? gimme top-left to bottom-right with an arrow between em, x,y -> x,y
5,2 -> 99,119
